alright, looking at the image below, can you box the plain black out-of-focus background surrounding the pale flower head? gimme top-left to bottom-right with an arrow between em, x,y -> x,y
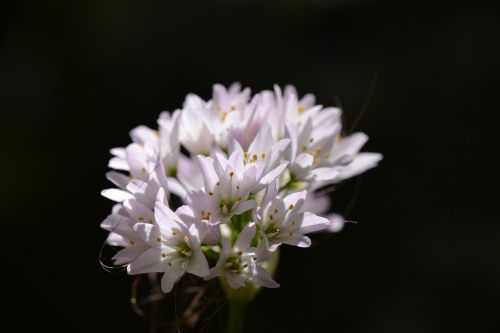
0,0 -> 500,333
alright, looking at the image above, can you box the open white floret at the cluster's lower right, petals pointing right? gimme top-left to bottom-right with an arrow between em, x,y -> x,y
257,184 -> 329,251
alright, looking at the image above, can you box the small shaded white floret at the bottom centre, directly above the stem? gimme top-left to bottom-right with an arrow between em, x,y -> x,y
208,222 -> 279,289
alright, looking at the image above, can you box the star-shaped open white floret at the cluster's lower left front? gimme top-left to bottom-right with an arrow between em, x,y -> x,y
127,188 -> 209,293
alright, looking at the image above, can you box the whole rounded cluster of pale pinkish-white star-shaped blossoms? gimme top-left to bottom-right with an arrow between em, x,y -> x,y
101,84 -> 382,293
